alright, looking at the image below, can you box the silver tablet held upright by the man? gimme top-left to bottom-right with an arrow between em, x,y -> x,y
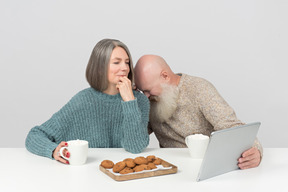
197,122 -> 260,181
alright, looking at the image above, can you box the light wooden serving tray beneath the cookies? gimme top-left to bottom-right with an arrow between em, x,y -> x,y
99,159 -> 177,181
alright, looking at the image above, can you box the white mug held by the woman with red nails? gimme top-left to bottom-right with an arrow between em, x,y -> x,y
59,140 -> 88,165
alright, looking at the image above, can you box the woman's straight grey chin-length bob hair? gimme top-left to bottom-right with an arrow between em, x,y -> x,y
86,39 -> 134,92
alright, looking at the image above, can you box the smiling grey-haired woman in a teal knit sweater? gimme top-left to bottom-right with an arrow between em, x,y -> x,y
26,39 -> 149,164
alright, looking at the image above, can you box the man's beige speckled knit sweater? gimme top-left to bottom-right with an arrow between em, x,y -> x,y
149,74 -> 262,155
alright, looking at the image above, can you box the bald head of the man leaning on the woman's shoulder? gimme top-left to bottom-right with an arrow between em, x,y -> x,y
134,55 -> 178,97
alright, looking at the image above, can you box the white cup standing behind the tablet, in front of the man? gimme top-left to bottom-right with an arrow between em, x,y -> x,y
185,134 -> 209,159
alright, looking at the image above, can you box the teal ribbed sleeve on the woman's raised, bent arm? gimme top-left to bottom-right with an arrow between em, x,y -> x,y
121,93 -> 149,153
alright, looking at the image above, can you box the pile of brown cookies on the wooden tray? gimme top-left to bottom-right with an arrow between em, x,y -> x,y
101,155 -> 161,174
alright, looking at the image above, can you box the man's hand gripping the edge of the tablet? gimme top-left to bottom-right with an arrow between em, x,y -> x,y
238,147 -> 261,169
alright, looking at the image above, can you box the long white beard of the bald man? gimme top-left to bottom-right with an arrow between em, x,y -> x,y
150,84 -> 179,123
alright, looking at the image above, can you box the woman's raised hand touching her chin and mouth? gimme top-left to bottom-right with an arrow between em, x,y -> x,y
116,77 -> 135,101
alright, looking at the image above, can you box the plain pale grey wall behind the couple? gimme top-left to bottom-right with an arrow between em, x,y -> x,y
0,0 -> 288,147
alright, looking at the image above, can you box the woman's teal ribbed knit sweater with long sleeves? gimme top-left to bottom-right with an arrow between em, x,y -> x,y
25,88 -> 150,159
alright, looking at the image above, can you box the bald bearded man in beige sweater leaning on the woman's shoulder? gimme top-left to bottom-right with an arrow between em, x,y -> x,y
135,55 -> 262,169
